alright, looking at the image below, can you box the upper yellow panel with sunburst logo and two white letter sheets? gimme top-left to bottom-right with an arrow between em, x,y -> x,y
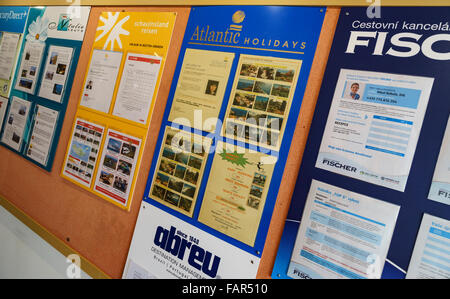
80,12 -> 176,125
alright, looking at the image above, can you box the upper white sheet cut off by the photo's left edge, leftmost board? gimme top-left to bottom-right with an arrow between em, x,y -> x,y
0,32 -> 20,80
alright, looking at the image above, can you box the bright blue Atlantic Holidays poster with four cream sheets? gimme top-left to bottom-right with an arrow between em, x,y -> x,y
125,6 -> 325,277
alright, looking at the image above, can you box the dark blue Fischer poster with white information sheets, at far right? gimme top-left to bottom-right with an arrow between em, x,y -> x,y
272,7 -> 450,278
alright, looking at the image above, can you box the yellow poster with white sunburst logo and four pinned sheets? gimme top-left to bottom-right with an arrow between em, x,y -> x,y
61,12 -> 176,210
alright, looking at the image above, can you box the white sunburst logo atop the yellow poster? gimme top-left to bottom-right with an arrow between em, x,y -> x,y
95,12 -> 130,51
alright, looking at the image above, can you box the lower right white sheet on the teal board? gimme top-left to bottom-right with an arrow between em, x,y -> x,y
27,105 -> 58,165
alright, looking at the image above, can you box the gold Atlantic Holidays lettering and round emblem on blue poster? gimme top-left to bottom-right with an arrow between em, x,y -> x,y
190,10 -> 306,50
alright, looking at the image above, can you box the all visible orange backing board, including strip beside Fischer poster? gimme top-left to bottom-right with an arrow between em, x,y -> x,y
0,6 -> 340,278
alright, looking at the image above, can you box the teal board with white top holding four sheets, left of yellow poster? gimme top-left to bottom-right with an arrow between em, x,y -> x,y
0,6 -> 90,171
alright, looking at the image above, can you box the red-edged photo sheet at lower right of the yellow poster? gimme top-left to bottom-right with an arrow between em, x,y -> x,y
94,129 -> 141,206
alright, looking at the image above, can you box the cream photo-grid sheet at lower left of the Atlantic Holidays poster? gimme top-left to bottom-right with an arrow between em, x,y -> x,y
149,127 -> 211,217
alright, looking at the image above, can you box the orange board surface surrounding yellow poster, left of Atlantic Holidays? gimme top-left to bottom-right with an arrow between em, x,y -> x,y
0,6 -> 190,278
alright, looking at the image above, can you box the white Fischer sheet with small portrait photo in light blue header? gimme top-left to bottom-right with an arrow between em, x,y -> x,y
316,69 -> 434,191
